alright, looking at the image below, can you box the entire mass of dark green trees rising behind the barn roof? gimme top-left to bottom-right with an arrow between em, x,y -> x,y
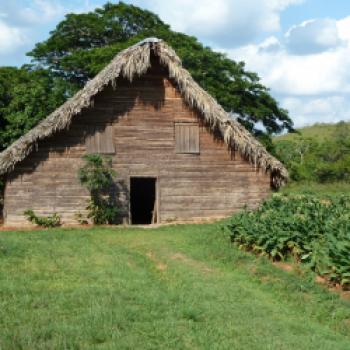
0,2 -> 293,151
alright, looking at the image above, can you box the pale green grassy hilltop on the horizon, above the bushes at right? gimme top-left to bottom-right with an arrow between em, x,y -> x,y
274,122 -> 350,142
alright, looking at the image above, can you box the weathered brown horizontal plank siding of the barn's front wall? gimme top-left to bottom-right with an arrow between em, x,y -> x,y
4,60 -> 270,225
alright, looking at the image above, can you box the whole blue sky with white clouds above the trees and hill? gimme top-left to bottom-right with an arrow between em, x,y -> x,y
0,0 -> 350,126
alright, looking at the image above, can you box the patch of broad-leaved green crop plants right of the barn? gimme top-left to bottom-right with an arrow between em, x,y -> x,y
228,194 -> 350,288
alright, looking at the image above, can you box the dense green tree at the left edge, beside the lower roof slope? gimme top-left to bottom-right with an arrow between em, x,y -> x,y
0,66 -> 69,151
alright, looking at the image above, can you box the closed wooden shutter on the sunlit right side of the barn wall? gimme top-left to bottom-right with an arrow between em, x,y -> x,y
175,123 -> 199,154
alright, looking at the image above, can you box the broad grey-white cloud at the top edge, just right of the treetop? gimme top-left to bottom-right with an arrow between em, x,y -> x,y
130,0 -> 303,48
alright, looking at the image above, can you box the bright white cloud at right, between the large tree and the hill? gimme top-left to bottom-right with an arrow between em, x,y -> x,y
228,21 -> 350,96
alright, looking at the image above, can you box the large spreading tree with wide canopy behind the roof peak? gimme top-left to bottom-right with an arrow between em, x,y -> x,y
28,2 -> 293,141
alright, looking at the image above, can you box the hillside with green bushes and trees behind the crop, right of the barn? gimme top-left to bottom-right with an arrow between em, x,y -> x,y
273,121 -> 350,183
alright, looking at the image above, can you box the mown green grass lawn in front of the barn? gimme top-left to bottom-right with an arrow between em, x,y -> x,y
0,224 -> 350,350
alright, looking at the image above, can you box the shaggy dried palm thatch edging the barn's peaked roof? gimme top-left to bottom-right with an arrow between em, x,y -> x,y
0,38 -> 288,187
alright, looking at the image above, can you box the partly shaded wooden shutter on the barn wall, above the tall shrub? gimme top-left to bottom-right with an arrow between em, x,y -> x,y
86,125 -> 115,154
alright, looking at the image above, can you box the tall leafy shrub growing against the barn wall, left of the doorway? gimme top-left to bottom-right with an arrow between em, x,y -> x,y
78,154 -> 118,225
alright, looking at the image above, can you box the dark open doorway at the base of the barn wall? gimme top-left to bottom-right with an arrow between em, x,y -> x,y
130,177 -> 157,225
